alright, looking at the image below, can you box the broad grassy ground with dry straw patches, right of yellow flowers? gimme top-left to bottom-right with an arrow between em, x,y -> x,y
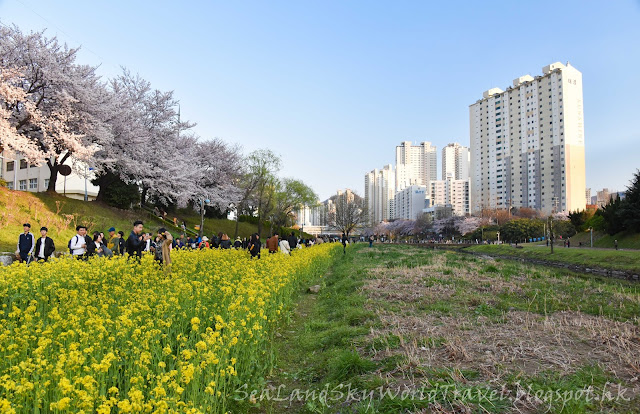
255,244 -> 640,413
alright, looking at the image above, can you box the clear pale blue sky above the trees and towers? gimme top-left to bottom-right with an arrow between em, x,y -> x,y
0,0 -> 640,199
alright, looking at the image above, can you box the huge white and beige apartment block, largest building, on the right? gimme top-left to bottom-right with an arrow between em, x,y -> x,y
469,63 -> 586,217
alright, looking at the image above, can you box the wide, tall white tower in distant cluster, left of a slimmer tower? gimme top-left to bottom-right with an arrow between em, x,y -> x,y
395,141 -> 438,191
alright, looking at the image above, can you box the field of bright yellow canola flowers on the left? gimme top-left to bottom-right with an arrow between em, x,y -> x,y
0,244 -> 338,414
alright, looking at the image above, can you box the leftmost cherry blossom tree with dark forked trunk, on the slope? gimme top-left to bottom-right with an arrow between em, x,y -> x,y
0,26 -> 112,191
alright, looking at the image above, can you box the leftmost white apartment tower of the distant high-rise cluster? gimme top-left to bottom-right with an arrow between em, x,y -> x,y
364,164 -> 396,225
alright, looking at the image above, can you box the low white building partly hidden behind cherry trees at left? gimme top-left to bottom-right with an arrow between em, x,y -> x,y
0,151 -> 100,200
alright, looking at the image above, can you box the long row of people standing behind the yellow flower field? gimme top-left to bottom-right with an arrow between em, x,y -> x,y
16,220 -> 347,265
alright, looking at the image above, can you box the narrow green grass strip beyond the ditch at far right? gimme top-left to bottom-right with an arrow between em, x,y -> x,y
467,244 -> 640,272
